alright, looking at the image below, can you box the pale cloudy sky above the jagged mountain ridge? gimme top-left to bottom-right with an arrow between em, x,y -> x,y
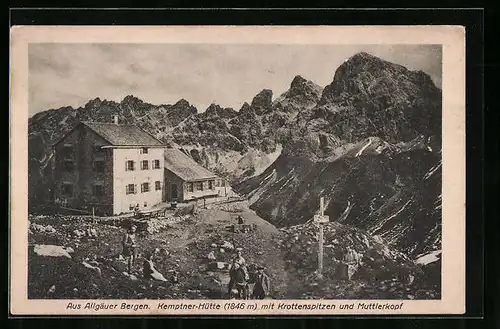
29,44 -> 442,115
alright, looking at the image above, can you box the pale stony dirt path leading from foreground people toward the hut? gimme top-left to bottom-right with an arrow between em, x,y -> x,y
161,209 -> 287,297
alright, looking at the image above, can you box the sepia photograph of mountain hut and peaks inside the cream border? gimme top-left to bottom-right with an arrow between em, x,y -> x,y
11,27 -> 465,313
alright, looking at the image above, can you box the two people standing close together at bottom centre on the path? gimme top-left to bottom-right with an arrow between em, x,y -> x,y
228,249 -> 270,299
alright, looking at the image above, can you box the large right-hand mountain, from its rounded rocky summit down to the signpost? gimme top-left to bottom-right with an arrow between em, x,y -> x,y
235,53 -> 441,257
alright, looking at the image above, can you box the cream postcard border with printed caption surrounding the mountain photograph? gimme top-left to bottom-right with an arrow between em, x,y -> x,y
9,26 -> 465,316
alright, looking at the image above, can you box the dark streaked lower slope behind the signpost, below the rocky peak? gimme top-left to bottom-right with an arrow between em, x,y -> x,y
235,141 -> 441,255
